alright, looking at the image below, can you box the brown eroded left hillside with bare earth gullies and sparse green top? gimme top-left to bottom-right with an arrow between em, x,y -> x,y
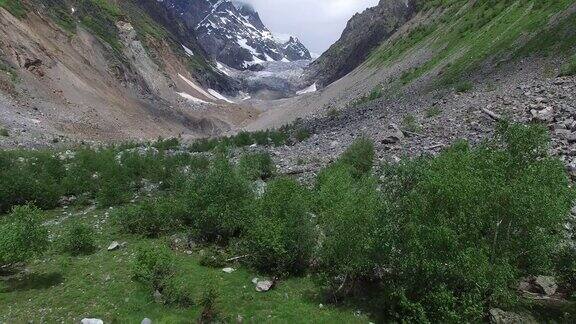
0,0 -> 254,146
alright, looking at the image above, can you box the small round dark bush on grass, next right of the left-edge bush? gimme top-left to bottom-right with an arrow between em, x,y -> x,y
58,221 -> 97,256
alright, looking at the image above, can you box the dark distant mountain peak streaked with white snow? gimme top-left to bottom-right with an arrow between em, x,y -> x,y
159,0 -> 311,70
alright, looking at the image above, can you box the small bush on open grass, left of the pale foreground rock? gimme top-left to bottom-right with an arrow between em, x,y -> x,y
132,243 -> 176,292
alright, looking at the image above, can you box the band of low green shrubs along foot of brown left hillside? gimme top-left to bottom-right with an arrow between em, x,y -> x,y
0,143 -> 209,213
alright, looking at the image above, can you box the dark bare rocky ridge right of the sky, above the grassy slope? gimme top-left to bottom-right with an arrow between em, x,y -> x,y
306,0 -> 417,86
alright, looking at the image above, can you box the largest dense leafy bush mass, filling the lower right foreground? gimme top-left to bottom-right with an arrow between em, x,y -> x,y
316,125 -> 574,322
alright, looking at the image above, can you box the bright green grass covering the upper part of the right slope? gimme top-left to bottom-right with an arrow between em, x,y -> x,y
369,0 -> 576,87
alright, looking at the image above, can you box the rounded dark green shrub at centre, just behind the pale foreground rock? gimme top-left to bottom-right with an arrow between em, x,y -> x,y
245,178 -> 316,275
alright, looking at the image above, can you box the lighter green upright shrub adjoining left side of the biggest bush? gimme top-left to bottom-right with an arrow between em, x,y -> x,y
315,163 -> 388,294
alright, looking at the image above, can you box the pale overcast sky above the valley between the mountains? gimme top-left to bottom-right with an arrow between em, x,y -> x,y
244,0 -> 378,54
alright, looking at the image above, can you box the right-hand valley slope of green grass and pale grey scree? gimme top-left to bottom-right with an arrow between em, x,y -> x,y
284,0 -> 576,124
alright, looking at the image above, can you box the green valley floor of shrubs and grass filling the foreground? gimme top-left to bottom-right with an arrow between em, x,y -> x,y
0,123 -> 576,323
